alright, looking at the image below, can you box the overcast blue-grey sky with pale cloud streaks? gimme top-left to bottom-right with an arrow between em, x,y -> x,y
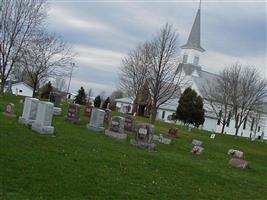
48,0 -> 267,95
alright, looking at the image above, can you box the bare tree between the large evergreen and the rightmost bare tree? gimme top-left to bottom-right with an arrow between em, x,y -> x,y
201,70 -> 232,134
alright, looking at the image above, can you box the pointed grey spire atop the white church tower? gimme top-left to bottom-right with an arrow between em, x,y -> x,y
181,0 -> 205,52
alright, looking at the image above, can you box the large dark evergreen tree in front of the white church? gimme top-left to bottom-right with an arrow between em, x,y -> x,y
176,88 -> 205,127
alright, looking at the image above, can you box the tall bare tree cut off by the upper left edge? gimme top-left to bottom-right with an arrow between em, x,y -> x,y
0,0 -> 46,93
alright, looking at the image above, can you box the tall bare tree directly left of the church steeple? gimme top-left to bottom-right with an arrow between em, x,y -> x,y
147,24 -> 186,123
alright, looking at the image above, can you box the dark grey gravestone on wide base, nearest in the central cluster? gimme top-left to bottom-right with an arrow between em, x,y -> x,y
130,124 -> 156,151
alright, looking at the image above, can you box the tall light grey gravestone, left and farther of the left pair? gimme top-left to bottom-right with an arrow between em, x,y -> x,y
19,97 -> 39,125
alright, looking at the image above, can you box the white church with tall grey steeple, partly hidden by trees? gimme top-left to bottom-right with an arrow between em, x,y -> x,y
116,1 -> 267,139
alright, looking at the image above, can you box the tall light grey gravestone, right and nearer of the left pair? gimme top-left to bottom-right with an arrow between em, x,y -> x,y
32,101 -> 54,134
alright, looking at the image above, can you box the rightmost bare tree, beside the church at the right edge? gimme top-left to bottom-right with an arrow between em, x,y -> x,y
226,64 -> 267,135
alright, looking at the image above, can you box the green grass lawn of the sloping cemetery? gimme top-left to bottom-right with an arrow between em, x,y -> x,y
0,96 -> 267,200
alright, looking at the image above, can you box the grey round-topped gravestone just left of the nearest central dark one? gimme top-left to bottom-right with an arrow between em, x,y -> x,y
105,116 -> 127,140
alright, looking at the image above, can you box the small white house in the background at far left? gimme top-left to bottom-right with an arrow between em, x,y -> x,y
4,81 -> 33,97
